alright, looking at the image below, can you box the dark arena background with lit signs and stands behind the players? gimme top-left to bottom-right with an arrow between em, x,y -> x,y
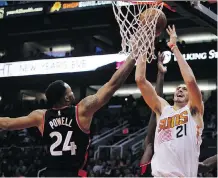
0,1 -> 218,177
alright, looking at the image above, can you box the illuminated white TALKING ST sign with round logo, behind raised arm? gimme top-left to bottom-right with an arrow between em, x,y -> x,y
163,49 -> 218,64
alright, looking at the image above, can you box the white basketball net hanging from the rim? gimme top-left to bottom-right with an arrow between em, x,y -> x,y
112,1 -> 163,63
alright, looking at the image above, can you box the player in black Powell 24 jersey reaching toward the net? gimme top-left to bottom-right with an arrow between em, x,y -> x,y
0,54 -> 135,177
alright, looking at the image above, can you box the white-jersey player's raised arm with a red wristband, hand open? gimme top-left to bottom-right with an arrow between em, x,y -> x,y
167,25 -> 204,115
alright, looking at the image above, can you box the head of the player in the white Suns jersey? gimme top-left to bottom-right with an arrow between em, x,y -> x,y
173,84 -> 189,104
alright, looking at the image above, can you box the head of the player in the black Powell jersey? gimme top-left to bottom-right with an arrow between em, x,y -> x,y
45,80 -> 75,106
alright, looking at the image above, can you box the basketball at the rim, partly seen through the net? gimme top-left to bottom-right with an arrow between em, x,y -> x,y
140,8 -> 167,37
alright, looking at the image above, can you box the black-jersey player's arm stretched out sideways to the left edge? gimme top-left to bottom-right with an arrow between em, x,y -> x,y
0,110 -> 44,131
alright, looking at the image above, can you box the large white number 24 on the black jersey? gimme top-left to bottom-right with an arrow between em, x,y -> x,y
49,131 -> 77,156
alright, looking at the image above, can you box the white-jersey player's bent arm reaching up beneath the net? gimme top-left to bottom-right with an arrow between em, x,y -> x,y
135,55 -> 167,115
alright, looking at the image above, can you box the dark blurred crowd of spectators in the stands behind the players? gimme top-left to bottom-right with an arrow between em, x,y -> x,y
0,91 -> 217,177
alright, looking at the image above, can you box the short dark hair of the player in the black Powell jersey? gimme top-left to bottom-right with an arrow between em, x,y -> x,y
45,80 -> 66,106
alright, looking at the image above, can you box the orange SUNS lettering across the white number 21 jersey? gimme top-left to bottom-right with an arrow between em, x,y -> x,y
158,111 -> 188,132
